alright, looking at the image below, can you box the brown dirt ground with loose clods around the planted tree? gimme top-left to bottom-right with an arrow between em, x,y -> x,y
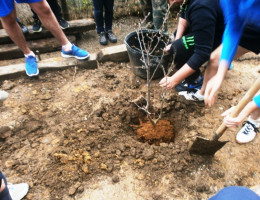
0,17 -> 260,200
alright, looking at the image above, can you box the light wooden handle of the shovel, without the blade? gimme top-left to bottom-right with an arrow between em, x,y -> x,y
212,77 -> 260,140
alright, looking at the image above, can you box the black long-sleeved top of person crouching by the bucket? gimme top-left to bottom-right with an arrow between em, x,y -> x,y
181,0 -> 225,70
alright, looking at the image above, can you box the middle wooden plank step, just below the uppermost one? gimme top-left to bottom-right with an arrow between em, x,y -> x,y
0,35 -> 76,60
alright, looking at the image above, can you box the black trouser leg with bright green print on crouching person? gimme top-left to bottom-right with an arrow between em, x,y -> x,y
170,34 -> 200,83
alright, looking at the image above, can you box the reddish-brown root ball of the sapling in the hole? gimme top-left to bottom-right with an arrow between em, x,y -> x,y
136,120 -> 174,145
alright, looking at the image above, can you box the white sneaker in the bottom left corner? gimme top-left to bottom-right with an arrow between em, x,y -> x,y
7,183 -> 29,200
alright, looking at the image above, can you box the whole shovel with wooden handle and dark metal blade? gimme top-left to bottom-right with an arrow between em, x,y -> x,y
189,78 -> 260,156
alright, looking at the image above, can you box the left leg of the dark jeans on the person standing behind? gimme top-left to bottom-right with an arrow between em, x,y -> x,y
93,0 -> 103,33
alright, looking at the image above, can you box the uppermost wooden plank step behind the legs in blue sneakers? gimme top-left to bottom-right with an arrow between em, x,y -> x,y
0,18 -> 96,44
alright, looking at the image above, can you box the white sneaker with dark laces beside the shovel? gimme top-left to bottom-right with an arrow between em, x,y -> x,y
236,121 -> 258,144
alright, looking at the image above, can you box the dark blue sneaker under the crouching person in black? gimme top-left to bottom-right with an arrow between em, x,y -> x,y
175,76 -> 203,92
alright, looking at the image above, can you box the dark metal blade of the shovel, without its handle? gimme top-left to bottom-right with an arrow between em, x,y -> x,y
189,137 -> 228,156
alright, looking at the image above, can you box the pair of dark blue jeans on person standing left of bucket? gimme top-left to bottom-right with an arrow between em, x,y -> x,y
93,0 -> 114,33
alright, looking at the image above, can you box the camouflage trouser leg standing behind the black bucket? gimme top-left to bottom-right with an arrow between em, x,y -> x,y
152,0 -> 168,34
